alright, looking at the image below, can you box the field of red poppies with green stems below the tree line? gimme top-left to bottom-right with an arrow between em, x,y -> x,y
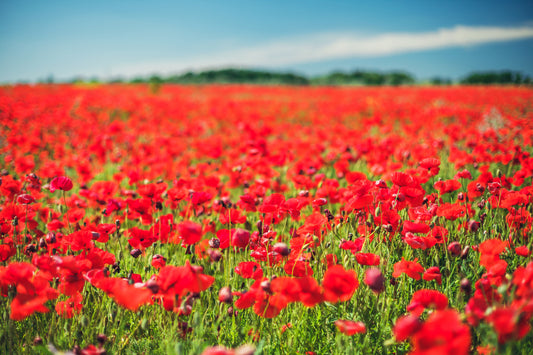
0,85 -> 533,355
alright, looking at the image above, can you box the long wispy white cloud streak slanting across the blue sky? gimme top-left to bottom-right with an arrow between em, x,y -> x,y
113,26 -> 533,75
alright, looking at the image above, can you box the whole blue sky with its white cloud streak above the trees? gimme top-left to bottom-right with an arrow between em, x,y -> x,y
0,0 -> 533,82
